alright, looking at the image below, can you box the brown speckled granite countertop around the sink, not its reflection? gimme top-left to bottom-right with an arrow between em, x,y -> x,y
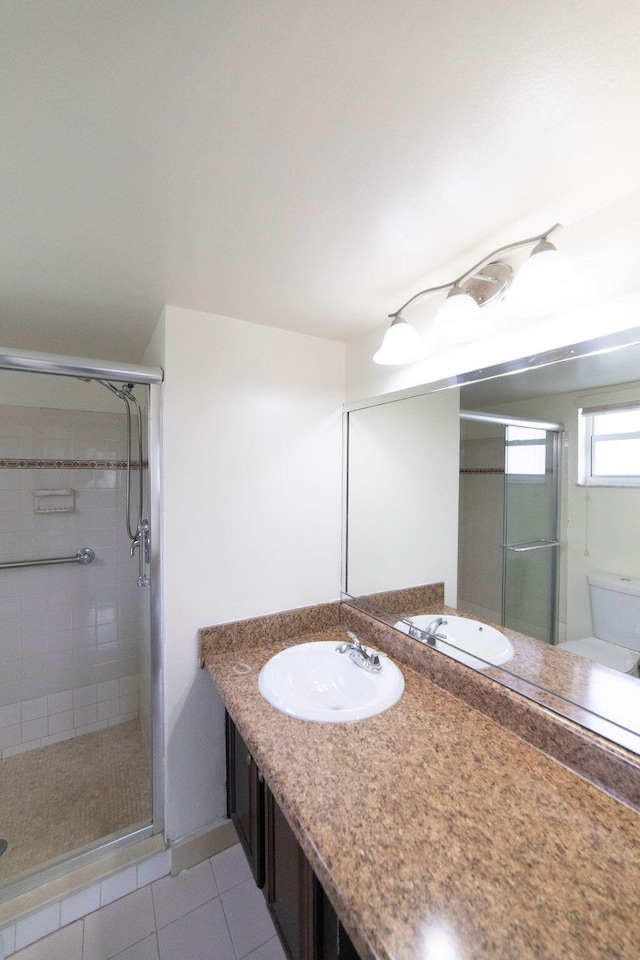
201,604 -> 640,960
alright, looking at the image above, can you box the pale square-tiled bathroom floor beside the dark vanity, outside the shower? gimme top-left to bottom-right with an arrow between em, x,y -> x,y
11,844 -> 285,960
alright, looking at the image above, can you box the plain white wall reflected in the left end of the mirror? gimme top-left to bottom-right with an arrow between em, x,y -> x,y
348,389 -> 459,606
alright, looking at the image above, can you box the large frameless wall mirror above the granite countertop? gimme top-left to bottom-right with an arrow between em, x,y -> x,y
343,329 -> 640,752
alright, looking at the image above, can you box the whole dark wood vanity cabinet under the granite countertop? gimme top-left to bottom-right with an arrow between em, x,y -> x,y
226,714 -> 359,960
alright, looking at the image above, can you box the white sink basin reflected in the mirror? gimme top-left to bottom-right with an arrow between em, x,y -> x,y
396,613 -> 514,670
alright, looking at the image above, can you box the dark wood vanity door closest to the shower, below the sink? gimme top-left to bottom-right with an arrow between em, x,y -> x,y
225,713 -> 265,887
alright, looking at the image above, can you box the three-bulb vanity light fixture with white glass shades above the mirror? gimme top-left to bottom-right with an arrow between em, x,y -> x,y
373,223 -> 570,365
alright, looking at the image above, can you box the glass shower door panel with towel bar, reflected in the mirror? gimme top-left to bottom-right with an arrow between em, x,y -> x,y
502,425 -> 559,643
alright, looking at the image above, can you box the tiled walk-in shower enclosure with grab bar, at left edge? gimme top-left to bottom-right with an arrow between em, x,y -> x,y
0,351 -> 163,896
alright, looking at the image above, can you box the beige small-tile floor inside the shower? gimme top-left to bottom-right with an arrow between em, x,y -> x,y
0,720 -> 151,884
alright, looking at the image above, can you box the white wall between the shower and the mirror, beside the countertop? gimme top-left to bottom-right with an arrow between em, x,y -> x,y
145,307 -> 344,839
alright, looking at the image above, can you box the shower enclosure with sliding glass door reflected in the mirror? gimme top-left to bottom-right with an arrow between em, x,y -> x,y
458,411 -> 561,643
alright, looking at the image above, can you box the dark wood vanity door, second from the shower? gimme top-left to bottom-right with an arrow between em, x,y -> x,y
265,790 -> 317,960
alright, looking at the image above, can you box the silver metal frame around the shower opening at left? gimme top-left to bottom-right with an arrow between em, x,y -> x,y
0,347 -> 165,897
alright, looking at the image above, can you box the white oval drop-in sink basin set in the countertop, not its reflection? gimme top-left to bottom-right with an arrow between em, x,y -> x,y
258,640 -> 404,723
